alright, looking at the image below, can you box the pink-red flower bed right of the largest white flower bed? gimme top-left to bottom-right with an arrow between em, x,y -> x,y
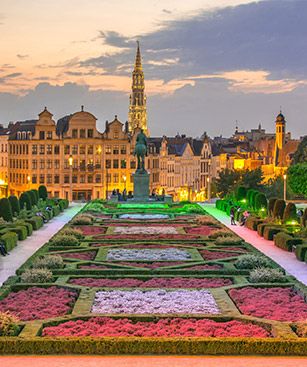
229,287 -> 307,321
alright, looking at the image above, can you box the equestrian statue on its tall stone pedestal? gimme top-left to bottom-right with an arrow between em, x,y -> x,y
133,130 -> 149,201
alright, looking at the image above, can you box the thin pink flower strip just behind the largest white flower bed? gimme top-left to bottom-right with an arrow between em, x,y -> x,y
70,277 -> 232,288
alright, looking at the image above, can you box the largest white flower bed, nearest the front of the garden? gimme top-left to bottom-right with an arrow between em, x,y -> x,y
92,289 -> 219,314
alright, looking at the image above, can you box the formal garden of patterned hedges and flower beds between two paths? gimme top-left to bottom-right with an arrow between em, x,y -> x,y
0,200 -> 307,355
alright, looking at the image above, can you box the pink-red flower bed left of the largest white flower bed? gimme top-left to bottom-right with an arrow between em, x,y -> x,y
0,287 -> 77,321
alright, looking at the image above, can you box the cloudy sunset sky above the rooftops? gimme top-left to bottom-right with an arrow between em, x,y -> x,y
0,0 -> 307,137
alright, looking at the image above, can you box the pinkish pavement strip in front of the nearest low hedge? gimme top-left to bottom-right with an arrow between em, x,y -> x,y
0,356 -> 307,367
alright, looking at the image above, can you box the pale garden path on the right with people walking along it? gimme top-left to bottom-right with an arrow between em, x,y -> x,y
200,203 -> 307,285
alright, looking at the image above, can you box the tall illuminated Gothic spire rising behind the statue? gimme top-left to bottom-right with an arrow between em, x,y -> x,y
128,41 -> 149,135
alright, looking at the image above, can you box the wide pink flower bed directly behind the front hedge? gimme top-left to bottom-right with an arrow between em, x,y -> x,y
42,317 -> 270,338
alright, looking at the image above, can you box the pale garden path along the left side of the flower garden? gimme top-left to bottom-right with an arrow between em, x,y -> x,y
0,203 -> 84,286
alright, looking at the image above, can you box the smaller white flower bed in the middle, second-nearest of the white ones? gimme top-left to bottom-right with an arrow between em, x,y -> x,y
107,248 -> 191,261
